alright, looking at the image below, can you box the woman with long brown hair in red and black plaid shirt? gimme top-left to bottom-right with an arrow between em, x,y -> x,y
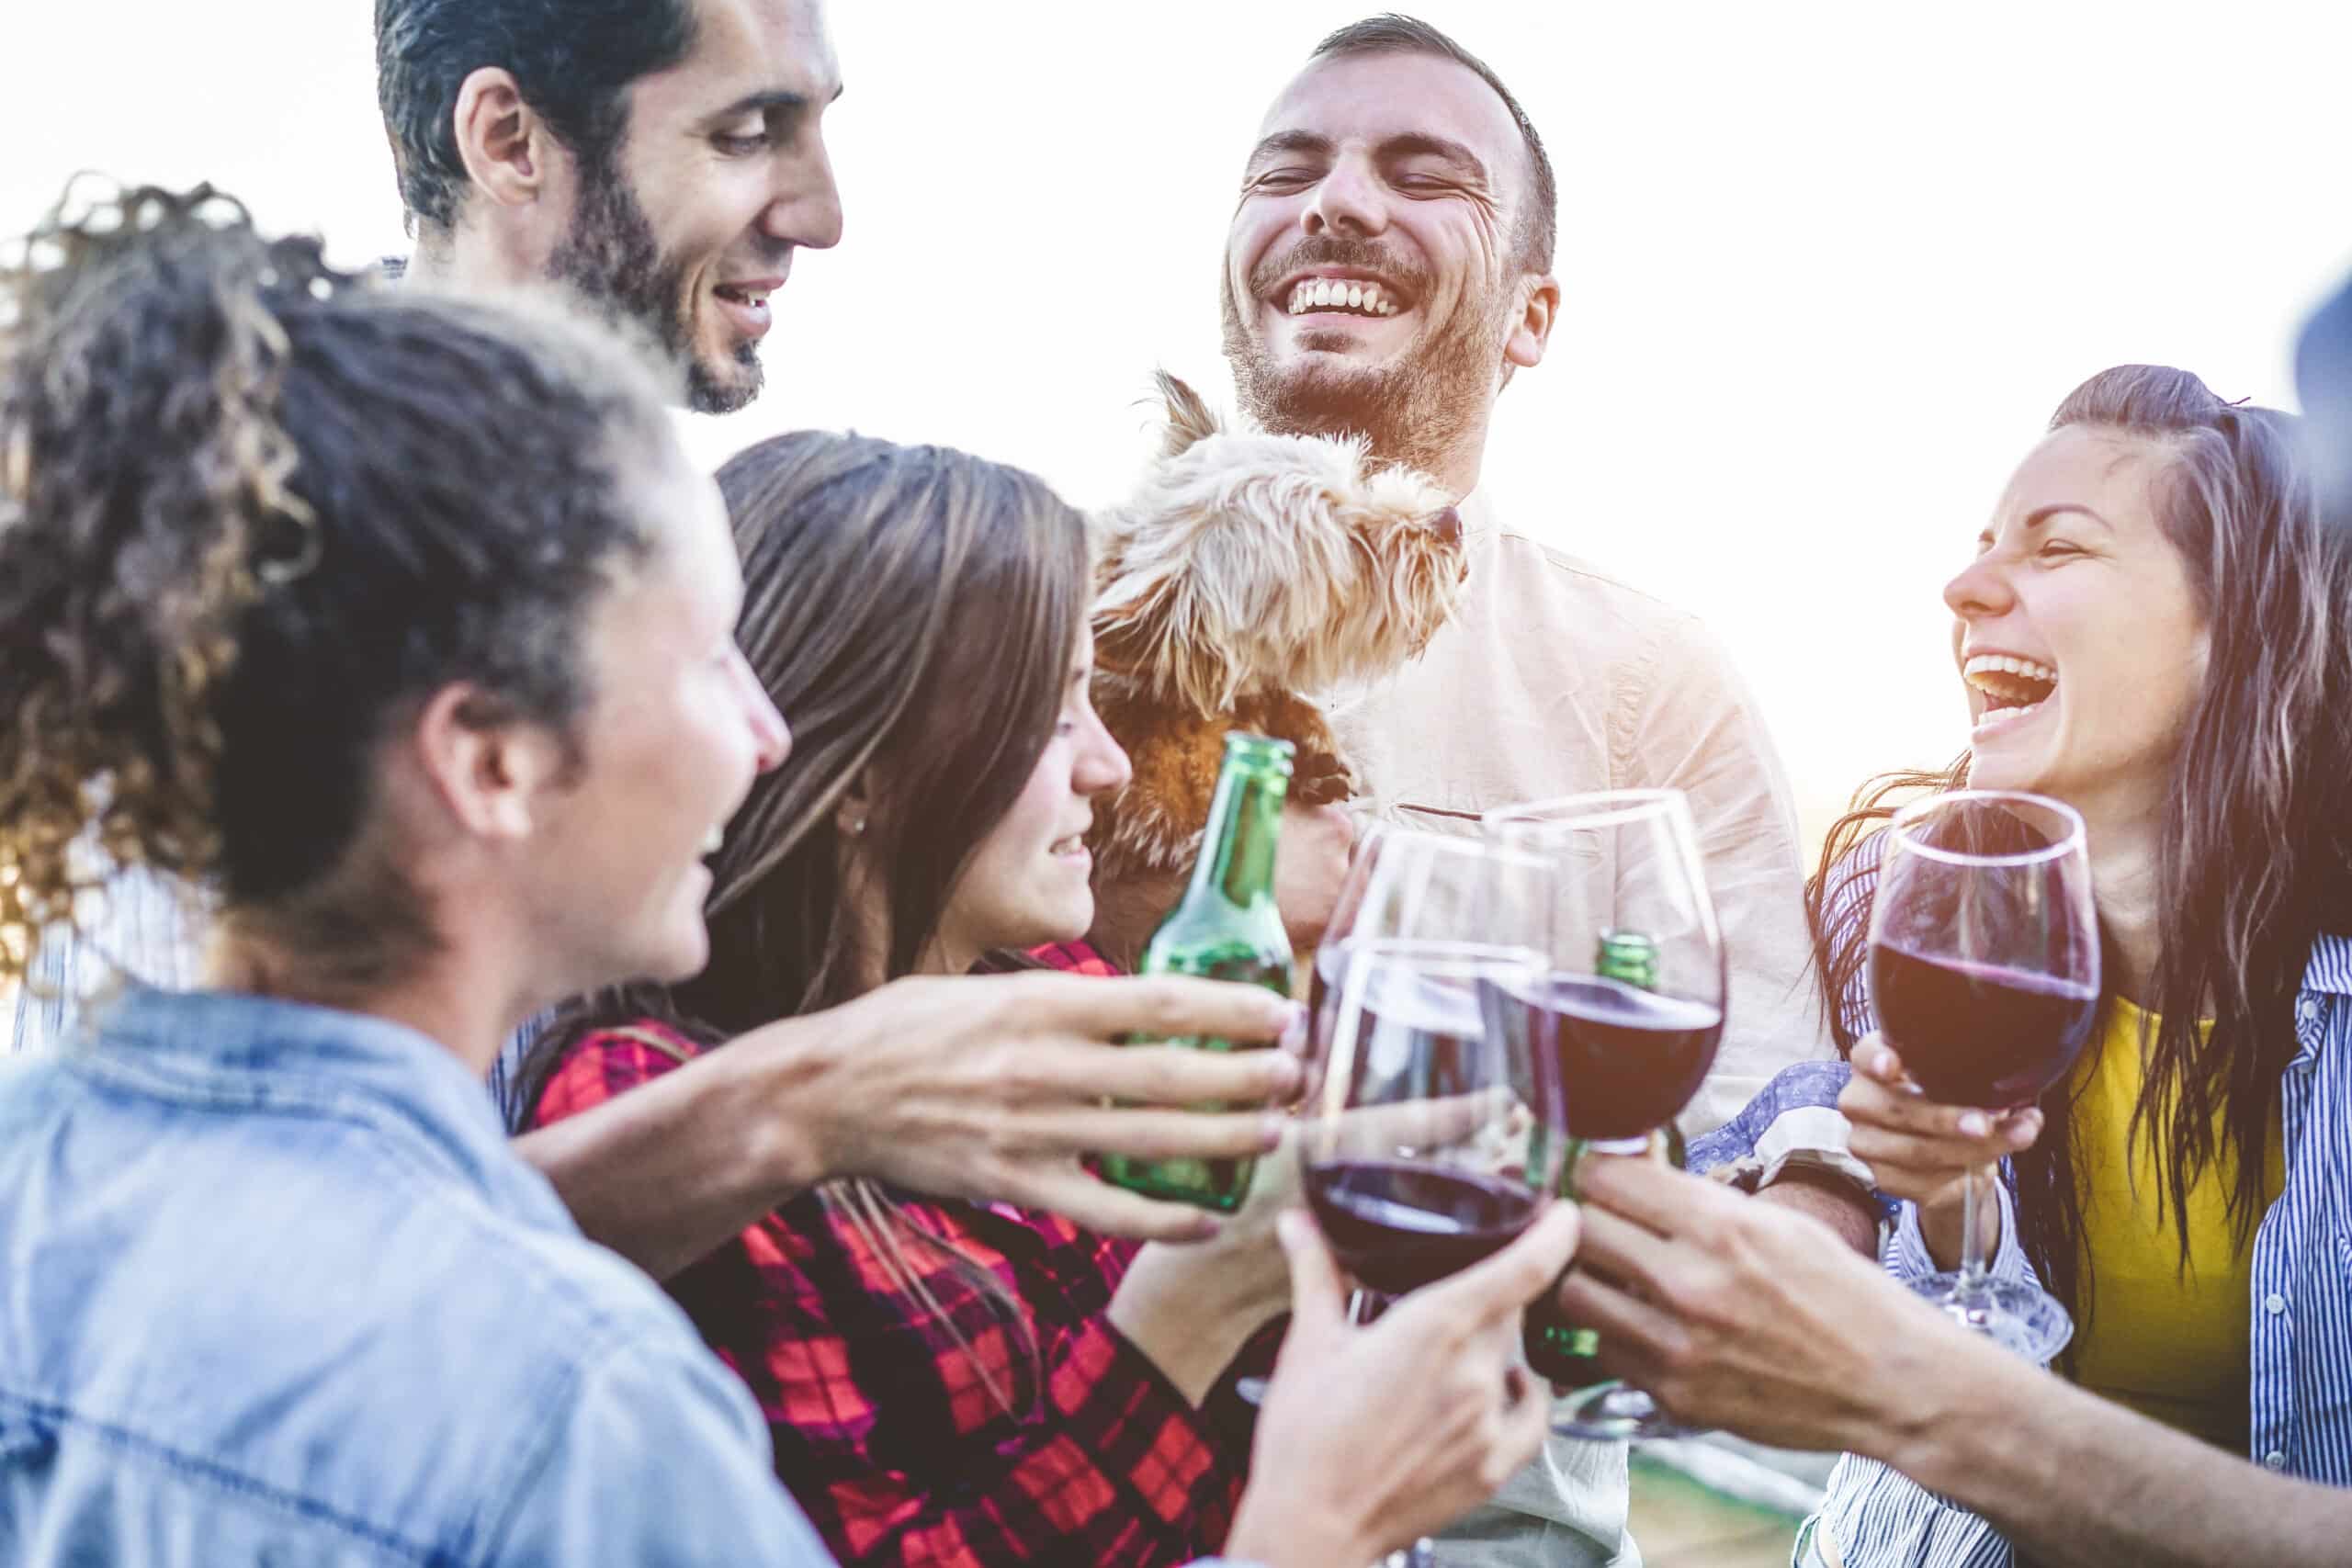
525,433 -> 1289,1563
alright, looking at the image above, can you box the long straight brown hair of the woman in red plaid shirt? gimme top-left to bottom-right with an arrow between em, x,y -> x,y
517,433 -> 1089,1417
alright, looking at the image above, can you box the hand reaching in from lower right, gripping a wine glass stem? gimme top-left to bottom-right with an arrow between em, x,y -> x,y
1559,1159 -> 1969,1453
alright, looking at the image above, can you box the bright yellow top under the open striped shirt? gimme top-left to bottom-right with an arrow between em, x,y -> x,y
2075,997 -> 2286,1455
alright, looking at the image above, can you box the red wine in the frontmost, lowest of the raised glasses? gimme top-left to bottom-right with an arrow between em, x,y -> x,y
1306,1159 -> 1541,1295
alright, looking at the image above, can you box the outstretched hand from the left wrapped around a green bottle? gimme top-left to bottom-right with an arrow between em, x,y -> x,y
790,974 -> 1301,1241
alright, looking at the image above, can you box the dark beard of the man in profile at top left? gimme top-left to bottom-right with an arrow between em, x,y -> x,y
548,157 -> 767,413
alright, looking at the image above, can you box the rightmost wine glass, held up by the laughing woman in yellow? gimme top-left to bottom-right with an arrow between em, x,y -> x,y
1870,790 -> 2100,1361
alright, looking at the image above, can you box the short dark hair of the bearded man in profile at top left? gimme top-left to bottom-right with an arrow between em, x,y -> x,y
377,0 -> 694,228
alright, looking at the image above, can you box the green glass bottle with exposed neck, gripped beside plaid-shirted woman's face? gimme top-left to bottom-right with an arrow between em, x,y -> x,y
1101,731 -> 1291,1213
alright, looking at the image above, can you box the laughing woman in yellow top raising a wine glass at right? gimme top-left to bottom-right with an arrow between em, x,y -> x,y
1809,367 -> 2352,1523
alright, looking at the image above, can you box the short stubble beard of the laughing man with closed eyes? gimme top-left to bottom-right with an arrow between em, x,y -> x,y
1218,270 -> 1503,472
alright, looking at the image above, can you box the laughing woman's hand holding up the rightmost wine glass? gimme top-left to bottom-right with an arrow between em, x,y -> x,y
1837,1034 -> 2041,1269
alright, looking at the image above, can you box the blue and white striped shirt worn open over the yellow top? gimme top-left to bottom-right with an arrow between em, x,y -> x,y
1799,936 -> 2352,1568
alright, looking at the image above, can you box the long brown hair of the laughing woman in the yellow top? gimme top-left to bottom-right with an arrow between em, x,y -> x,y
1806,365 -> 2352,1354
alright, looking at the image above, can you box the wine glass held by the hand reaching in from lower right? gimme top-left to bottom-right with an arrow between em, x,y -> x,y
1484,790 -> 1726,1438
